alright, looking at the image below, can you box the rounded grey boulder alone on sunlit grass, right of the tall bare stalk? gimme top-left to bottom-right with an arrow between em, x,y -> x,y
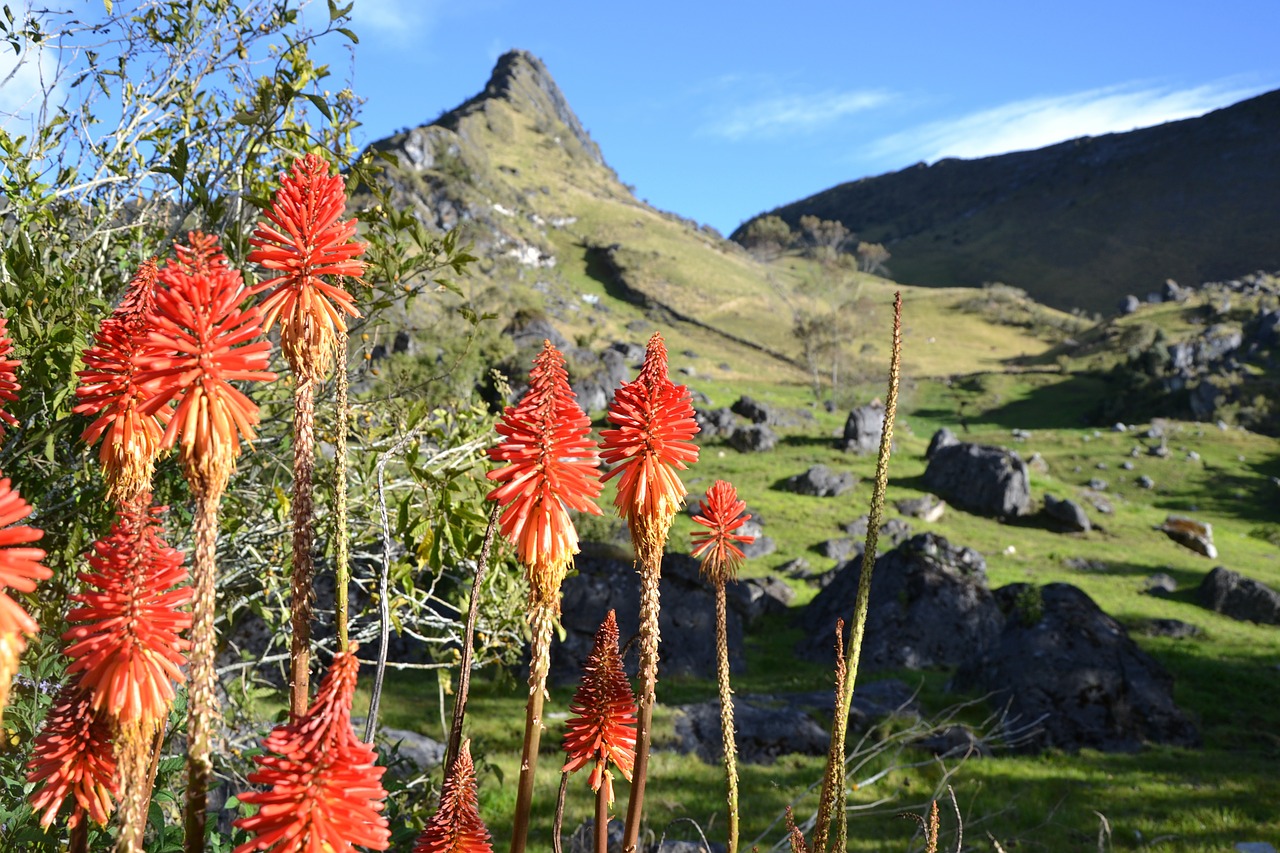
924,443 -> 1032,517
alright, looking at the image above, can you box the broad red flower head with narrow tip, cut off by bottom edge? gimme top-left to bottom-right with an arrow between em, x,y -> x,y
234,643 -> 390,853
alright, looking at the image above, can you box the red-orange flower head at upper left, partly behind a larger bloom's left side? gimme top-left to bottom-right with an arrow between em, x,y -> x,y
73,259 -> 173,502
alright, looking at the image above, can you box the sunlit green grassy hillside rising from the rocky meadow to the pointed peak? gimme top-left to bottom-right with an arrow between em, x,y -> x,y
348,54 -> 1280,850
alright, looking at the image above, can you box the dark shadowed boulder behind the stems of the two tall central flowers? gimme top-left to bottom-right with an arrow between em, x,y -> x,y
550,543 -> 749,684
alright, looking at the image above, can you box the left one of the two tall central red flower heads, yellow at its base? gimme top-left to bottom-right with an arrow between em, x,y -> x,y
488,341 -> 600,611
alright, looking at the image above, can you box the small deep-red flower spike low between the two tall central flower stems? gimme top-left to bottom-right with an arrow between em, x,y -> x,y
563,610 -> 636,806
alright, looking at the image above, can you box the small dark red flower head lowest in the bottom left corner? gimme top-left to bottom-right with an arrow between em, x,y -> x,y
27,676 -> 118,827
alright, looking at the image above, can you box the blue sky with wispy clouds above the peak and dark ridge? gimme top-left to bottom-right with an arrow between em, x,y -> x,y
312,0 -> 1280,233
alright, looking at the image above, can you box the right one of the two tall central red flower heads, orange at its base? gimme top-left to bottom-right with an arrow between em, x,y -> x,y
600,332 -> 698,535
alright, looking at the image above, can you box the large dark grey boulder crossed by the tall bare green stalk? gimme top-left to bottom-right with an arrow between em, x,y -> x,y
796,533 -> 1004,669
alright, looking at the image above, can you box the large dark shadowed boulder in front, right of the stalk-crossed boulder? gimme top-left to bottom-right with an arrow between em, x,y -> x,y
951,583 -> 1199,752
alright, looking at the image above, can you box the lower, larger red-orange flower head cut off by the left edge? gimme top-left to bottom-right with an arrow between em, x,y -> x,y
0,478 -> 54,716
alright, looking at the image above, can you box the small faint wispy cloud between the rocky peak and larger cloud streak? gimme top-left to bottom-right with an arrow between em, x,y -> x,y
700,90 -> 893,142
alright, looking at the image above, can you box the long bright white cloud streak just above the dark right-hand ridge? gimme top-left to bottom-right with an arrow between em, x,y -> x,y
867,81 -> 1267,163
